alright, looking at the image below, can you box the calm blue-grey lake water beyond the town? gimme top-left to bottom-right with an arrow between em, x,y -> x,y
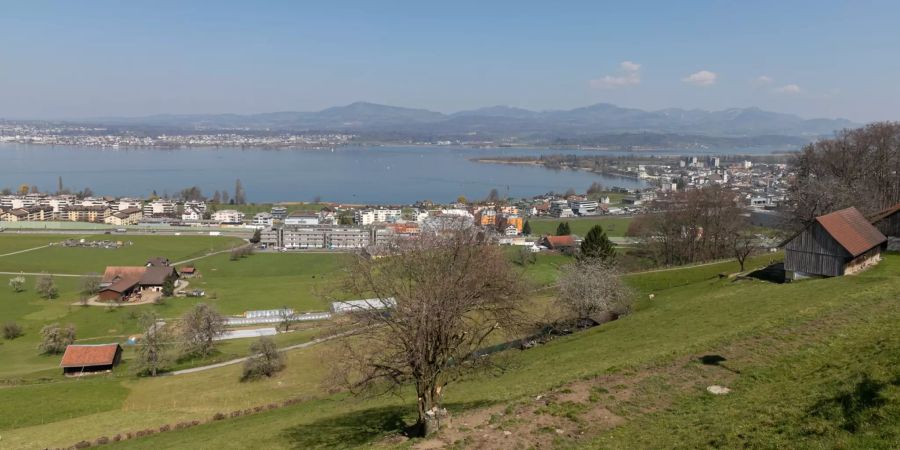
0,144 -> 772,204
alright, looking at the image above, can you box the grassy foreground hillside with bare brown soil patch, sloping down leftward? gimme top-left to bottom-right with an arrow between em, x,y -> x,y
12,255 -> 900,448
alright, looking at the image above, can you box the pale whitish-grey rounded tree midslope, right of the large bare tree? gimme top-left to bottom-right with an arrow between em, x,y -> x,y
557,258 -> 632,322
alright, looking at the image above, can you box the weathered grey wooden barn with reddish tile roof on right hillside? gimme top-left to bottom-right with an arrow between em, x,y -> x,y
782,208 -> 887,280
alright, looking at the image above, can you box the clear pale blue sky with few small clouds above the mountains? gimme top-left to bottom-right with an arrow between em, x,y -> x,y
0,0 -> 900,122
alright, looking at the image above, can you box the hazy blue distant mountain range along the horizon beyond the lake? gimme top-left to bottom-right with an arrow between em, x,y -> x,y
83,102 -> 858,140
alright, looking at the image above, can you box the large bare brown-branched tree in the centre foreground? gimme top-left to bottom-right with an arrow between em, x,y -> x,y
335,227 -> 523,435
